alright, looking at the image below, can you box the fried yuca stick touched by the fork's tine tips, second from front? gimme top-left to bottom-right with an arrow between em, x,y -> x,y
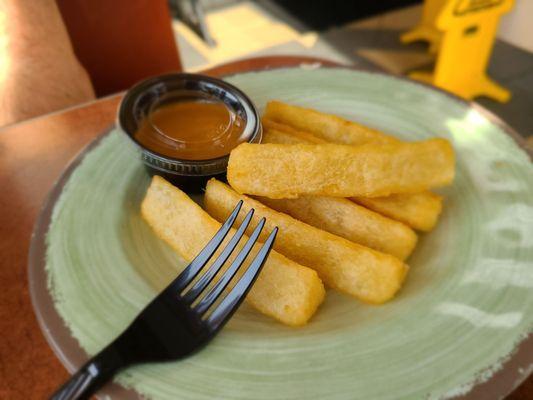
204,179 -> 408,304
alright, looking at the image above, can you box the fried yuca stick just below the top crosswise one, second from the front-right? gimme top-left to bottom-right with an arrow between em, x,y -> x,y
258,196 -> 417,260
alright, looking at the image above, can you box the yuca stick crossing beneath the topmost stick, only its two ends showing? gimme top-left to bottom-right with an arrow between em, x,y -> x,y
262,125 -> 442,231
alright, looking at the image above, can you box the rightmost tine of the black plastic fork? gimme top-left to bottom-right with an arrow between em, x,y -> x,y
207,227 -> 278,330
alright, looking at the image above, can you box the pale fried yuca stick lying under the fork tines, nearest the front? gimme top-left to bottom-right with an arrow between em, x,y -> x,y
141,176 -> 325,326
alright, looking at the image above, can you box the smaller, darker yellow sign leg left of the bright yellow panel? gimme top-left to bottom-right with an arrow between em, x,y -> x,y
400,0 -> 446,54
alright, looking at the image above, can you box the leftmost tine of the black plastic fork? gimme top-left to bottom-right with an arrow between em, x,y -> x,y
167,200 -> 242,292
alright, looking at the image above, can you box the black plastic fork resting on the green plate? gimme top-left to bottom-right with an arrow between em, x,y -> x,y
51,201 -> 278,400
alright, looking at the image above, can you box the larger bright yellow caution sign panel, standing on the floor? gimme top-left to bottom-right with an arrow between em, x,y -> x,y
410,0 -> 514,103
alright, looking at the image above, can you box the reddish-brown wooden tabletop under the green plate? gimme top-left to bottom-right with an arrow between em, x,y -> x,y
0,57 -> 533,400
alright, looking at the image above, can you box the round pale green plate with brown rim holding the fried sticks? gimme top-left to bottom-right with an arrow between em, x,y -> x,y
30,69 -> 533,400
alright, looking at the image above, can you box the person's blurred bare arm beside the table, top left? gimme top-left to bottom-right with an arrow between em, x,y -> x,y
0,0 -> 94,125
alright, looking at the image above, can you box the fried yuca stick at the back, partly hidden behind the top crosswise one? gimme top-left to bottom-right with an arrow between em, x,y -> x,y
264,101 -> 398,145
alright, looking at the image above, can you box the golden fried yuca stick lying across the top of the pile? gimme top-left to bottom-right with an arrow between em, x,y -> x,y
228,139 -> 455,199
